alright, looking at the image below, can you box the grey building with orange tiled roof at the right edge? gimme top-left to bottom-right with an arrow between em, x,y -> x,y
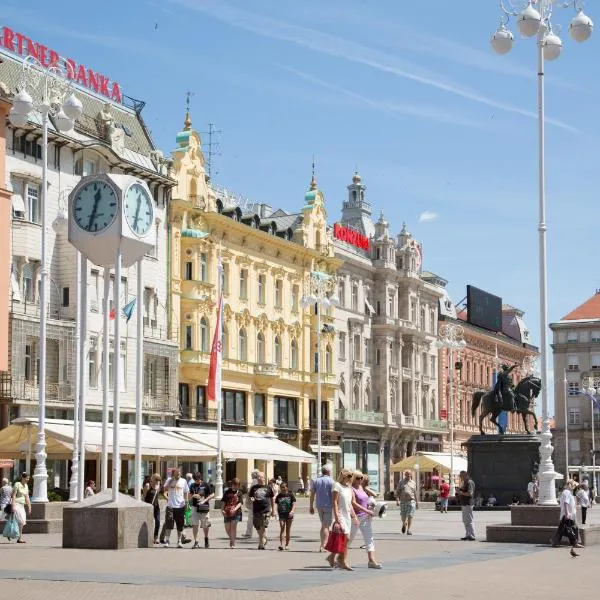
550,290 -> 600,473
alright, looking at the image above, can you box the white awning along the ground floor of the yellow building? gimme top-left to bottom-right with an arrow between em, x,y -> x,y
178,427 -> 315,463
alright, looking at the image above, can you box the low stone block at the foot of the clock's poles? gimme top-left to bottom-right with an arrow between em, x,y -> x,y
63,490 -> 154,550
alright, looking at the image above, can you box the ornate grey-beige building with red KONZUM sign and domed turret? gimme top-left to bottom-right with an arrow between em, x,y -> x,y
333,173 -> 447,491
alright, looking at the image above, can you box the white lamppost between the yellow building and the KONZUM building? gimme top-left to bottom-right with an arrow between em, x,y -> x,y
302,271 -> 339,469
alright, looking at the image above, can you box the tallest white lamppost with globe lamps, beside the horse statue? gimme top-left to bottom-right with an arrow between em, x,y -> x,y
491,0 -> 594,506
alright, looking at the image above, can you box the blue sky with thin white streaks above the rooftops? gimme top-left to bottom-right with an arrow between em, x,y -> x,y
0,0 -> 600,404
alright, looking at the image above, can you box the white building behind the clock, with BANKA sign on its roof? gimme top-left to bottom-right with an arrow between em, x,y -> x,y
0,34 -> 178,487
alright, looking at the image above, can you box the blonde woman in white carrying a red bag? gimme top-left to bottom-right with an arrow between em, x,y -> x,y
325,469 -> 358,571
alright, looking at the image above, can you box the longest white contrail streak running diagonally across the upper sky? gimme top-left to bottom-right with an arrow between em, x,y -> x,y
171,0 -> 581,133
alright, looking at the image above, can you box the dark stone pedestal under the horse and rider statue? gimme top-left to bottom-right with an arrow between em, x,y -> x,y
465,435 -> 540,506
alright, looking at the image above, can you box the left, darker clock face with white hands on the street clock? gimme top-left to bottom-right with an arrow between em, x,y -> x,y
73,181 -> 118,234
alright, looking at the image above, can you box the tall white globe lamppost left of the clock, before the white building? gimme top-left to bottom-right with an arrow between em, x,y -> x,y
8,56 -> 83,502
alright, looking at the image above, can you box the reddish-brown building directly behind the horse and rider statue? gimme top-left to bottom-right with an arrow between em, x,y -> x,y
439,297 -> 541,454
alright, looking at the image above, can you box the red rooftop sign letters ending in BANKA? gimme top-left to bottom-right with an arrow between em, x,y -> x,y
0,27 -> 122,102
